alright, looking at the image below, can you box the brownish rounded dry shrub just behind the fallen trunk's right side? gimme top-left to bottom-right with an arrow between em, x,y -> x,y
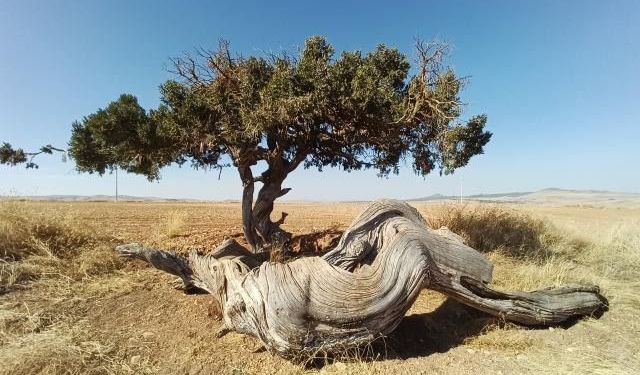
427,204 -> 547,257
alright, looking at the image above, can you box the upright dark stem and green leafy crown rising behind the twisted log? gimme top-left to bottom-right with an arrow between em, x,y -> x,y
69,37 -> 491,251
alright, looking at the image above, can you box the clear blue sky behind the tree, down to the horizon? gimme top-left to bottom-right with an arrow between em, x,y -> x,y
0,0 -> 640,200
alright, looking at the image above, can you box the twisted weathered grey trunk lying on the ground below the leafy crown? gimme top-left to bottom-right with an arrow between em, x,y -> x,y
118,201 -> 606,357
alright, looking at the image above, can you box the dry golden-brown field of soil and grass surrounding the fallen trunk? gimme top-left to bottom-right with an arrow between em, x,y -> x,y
0,201 -> 640,374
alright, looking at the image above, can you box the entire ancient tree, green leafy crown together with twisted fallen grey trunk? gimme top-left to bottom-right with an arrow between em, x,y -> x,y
0,37 -> 606,357
